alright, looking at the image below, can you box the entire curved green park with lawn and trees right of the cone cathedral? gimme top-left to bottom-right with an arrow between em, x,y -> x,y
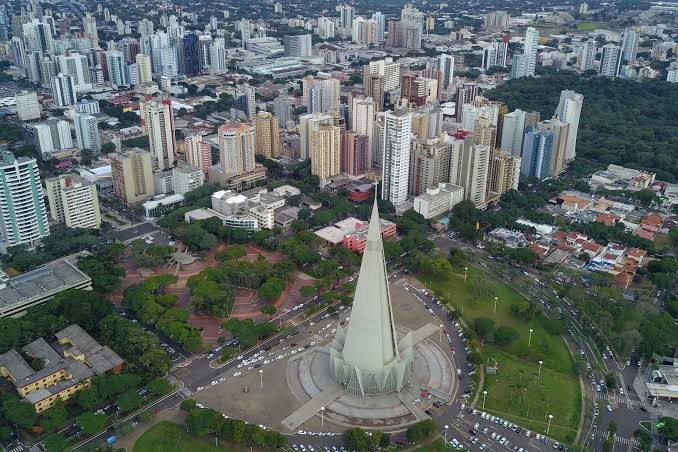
419,263 -> 582,443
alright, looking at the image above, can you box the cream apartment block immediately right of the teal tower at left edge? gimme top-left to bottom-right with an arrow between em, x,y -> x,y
45,174 -> 101,229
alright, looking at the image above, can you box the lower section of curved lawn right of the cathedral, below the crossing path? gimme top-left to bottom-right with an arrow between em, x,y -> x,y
478,347 -> 581,443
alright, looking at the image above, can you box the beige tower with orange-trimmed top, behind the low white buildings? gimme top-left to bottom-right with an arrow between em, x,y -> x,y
219,123 -> 256,177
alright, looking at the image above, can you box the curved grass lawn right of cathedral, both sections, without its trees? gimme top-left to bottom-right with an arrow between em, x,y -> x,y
420,266 -> 582,443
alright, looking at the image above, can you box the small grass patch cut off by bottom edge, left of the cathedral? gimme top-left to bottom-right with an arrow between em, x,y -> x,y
133,421 -> 245,452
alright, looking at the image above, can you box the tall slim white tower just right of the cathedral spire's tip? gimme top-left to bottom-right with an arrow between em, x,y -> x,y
381,110 -> 412,207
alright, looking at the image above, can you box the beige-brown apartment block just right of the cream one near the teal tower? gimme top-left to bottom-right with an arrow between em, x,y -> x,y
108,148 -> 155,204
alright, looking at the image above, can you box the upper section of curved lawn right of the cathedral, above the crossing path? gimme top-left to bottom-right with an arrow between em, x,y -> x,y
420,266 -> 573,375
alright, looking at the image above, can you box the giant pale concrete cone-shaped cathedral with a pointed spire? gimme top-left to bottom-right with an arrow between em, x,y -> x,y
330,198 -> 412,397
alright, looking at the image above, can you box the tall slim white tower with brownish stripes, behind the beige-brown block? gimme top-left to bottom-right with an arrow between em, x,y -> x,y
139,99 -> 176,171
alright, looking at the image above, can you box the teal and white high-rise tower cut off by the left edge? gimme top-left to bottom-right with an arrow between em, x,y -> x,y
0,151 -> 49,247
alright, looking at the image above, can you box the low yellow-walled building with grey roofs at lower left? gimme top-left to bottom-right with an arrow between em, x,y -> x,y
0,324 -> 124,414
